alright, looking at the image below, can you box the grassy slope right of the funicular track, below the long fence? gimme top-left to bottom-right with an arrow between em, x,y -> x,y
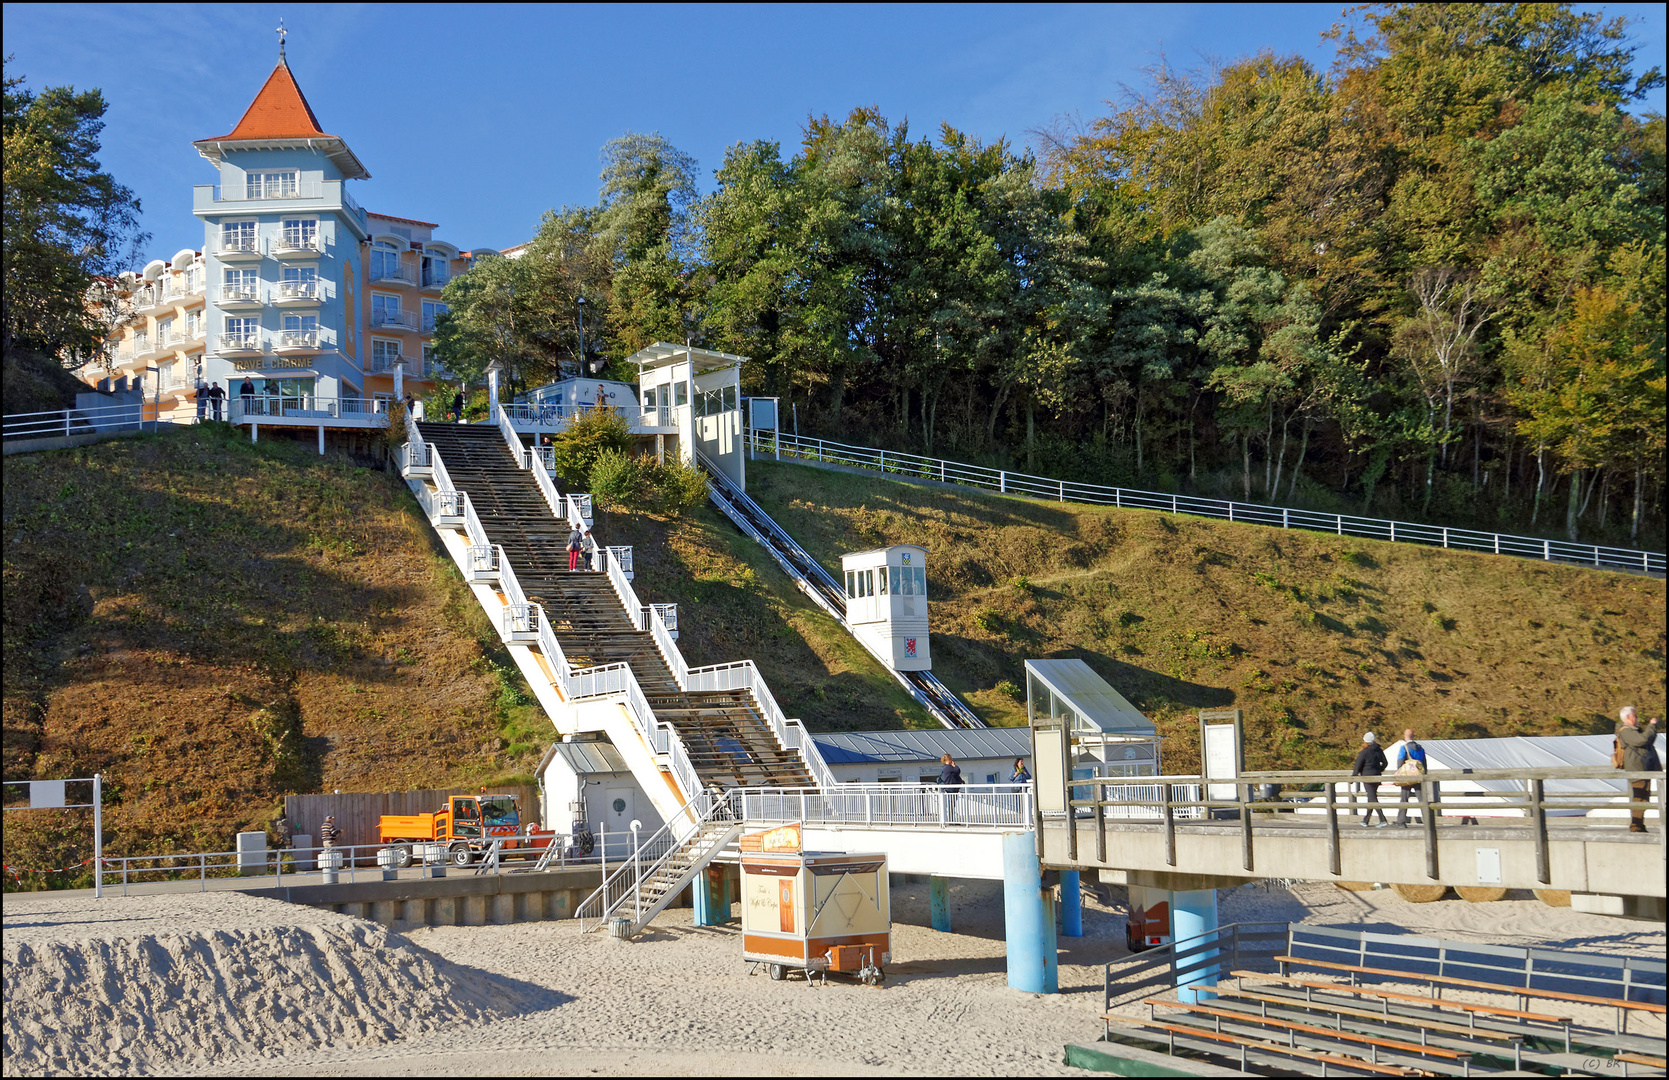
747,461 -> 1664,770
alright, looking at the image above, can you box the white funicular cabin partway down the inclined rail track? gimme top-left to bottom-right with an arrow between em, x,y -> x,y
841,544 -> 933,671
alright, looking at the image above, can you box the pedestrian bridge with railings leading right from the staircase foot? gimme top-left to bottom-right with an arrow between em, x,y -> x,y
738,768 -> 1666,898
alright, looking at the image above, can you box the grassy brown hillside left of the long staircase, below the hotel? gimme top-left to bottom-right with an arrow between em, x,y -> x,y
3,426 -> 549,886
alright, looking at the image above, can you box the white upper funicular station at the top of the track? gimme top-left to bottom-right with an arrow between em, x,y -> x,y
628,341 -> 748,491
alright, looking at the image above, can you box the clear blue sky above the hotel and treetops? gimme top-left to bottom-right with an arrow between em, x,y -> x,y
5,3 -> 1664,255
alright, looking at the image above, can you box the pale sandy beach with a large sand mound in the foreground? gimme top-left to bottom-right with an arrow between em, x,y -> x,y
3,881 -> 1666,1077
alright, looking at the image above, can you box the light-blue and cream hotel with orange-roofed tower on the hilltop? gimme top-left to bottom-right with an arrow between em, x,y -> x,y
82,50 -> 491,427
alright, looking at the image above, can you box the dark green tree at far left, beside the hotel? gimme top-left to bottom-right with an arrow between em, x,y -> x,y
3,57 -> 149,364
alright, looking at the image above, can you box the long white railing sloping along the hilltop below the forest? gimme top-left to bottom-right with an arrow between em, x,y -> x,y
748,429 -> 1664,574
